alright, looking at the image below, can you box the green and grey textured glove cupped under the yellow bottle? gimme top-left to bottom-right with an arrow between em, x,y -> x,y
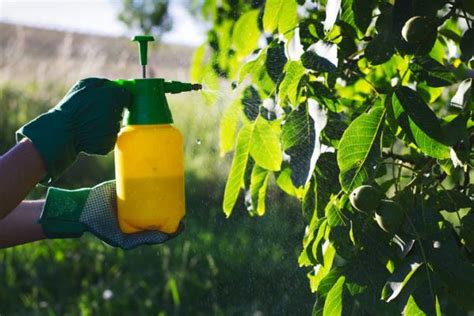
38,180 -> 183,249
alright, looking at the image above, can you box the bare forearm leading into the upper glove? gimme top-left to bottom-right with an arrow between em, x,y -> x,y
0,139 -> 46,221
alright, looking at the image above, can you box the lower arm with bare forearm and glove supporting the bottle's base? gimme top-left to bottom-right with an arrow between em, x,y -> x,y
0,181 -> 178,249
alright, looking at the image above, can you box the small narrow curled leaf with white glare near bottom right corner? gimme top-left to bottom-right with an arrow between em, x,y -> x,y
382,256 -> 423,302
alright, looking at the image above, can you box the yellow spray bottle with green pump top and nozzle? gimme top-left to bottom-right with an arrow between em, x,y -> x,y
115,36 -> 201,233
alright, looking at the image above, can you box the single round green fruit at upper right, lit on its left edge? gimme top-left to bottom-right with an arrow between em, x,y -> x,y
402,16 -> 438,55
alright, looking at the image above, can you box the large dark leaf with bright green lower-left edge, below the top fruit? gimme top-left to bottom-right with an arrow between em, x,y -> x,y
392,87 -> 450,159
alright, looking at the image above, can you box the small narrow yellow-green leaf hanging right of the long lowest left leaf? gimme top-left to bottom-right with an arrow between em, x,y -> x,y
250,164 -> 270,216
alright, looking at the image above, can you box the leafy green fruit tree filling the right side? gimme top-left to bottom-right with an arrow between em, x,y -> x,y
192,0 -> 474,315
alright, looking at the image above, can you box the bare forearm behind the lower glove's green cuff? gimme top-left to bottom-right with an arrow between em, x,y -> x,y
0,200 -> 45,248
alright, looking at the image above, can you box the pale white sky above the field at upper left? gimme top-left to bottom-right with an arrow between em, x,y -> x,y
0,0 -> 205,46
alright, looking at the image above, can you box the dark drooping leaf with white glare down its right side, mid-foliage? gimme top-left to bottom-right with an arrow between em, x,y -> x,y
281,100 -> 326,187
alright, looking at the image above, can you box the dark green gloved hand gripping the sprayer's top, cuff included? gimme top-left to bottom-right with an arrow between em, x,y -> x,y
16,78 -> 131,184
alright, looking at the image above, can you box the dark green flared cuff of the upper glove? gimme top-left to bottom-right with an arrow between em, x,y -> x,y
16,110 -> 77,185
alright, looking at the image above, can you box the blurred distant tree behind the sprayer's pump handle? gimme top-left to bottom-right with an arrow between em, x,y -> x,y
118,0 -> 172,38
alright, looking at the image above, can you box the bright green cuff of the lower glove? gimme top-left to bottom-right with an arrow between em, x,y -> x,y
38,188 -> 90,238
